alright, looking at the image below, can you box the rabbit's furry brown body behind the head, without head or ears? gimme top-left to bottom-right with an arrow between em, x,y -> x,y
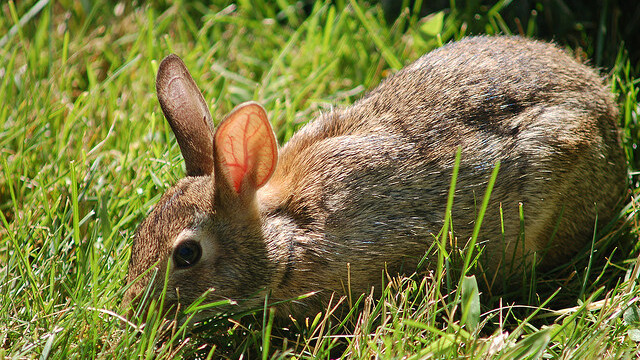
262,37 -> 626,296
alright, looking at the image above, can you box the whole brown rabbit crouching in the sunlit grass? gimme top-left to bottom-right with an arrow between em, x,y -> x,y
124,36 -> 627,316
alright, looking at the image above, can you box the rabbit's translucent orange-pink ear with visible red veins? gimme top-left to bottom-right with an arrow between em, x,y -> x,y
214,102 -> 278,201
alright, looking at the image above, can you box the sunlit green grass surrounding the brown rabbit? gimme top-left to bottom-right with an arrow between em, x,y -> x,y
0,0 -> 640,359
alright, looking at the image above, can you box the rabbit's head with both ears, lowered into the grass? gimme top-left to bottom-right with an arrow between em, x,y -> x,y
124,55 -> 278,320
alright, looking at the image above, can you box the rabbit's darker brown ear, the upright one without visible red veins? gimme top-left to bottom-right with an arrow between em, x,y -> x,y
156,54 -> 213,176
